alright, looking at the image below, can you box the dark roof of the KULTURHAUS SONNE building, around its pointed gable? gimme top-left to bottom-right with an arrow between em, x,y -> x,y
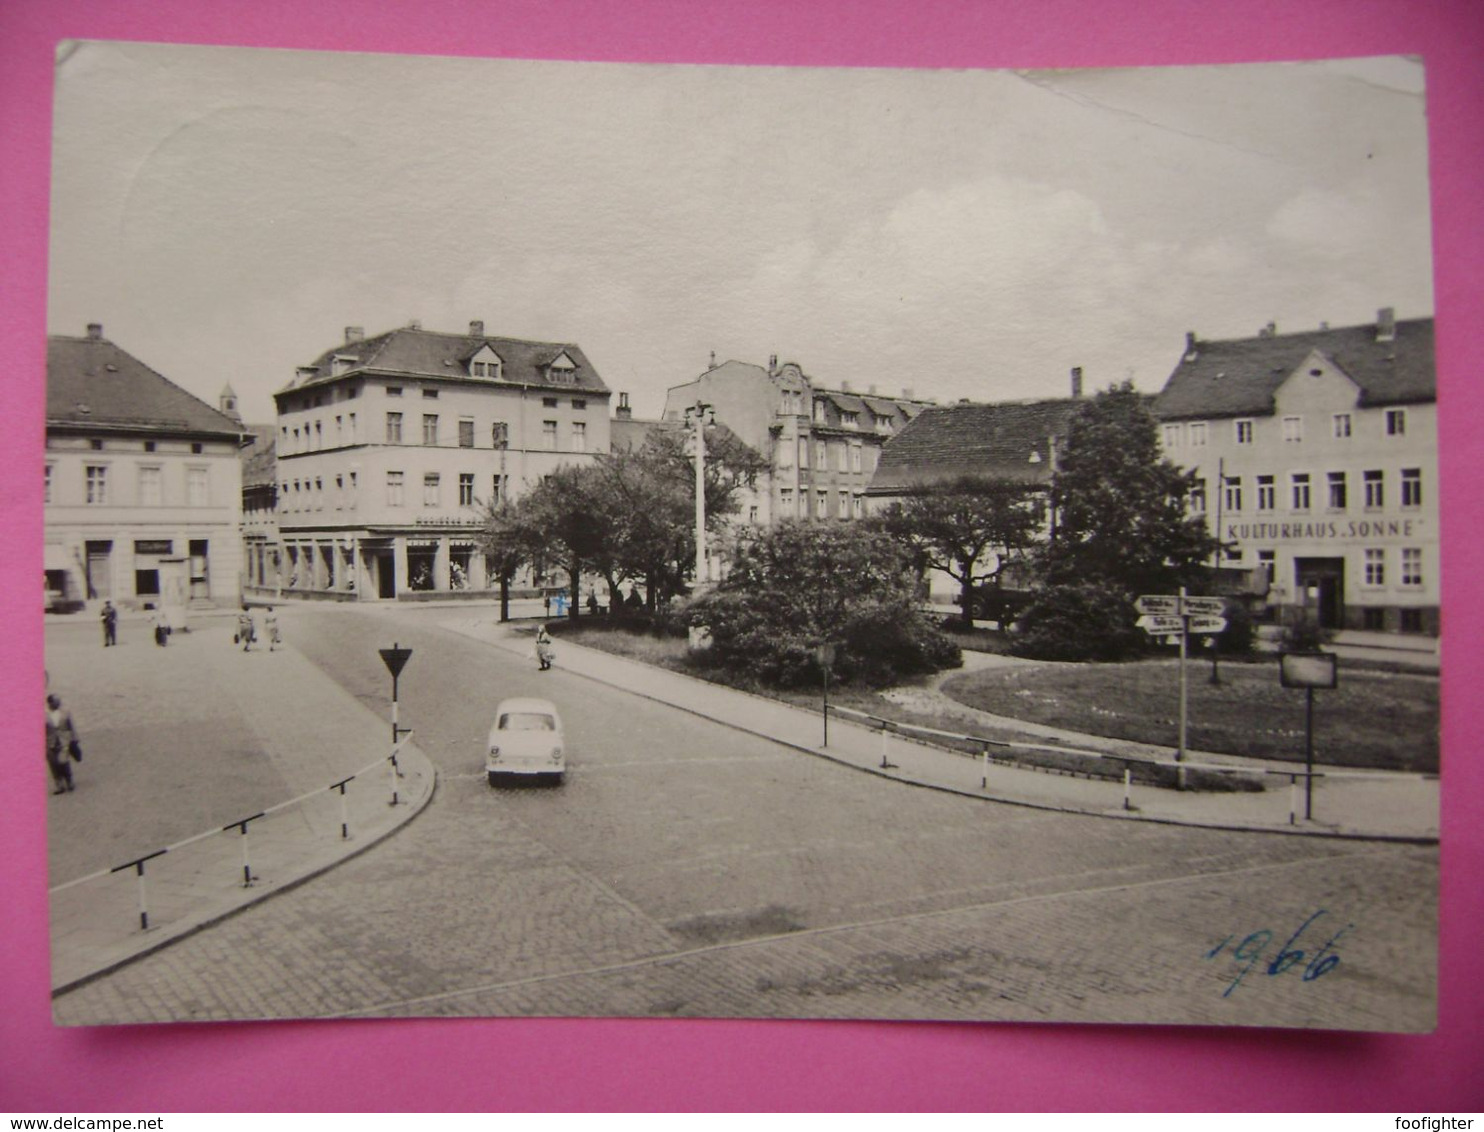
1155,319 -> 1438,420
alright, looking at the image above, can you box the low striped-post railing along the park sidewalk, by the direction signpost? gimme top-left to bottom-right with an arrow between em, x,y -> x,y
830,708 -> 1438,825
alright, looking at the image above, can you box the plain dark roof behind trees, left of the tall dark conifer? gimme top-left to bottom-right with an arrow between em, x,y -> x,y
870,398 -> 1086,496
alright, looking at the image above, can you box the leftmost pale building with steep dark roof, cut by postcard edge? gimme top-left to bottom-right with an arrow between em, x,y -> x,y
45,323 -> 243,608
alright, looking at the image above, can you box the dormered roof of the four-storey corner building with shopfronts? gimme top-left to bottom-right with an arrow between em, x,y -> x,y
279,326 -> 608,393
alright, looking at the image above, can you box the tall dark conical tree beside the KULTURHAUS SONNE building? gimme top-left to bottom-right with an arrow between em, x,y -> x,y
1039,381 -> 1218,595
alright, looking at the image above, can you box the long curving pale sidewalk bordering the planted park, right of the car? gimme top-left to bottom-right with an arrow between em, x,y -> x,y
442,610 -> 1439,843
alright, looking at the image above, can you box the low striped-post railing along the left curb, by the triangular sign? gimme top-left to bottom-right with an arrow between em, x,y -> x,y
47,731 -> 413,932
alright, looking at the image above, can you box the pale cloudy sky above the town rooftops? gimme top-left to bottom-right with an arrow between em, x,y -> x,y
47,42 -> 1432,421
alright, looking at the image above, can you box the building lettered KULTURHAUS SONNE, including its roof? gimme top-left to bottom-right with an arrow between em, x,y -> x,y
1155,309 -> 1438,634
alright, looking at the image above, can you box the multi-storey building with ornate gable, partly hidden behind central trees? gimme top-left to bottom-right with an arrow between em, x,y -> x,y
665,358 -> 929,525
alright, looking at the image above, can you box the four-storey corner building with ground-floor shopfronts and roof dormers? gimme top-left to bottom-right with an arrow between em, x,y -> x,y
273,322 -> 608,599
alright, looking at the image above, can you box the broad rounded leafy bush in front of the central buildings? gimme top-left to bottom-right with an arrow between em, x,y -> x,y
687,522 -> 960,685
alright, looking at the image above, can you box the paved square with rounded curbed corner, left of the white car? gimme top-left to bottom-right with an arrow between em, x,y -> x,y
47,616 -> 435,994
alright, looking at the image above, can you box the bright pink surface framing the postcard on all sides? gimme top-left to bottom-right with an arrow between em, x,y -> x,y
0,0 -> 1484,1113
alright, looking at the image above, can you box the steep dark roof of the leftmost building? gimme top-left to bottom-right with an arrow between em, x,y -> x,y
46,335 -> 242,438
